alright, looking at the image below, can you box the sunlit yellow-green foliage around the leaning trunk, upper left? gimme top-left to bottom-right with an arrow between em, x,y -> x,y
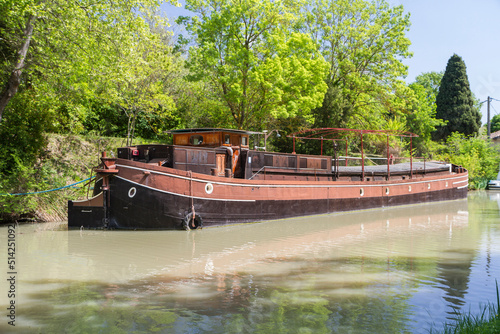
0,0 -> 180,142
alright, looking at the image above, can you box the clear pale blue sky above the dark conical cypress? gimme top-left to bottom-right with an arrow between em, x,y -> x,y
164,0 -> 500,124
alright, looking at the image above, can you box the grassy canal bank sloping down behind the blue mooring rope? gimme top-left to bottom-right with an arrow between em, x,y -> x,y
0,134 -> 150,222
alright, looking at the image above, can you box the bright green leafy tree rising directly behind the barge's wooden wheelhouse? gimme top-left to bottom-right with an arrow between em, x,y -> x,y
180,0 -> 326,128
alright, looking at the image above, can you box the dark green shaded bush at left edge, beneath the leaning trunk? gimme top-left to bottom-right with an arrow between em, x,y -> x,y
0,91 -> 65,221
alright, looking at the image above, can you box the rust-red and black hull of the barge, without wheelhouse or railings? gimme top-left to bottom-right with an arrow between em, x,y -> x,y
68,159 -> 468,229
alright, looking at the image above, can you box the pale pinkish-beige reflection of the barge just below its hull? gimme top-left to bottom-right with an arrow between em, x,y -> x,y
69,200 -> 468,280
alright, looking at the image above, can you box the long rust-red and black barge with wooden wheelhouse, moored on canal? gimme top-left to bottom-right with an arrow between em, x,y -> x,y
68,128 -> 468,230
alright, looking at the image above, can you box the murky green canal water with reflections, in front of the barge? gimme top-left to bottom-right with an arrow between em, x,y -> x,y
0,192 -> 500,333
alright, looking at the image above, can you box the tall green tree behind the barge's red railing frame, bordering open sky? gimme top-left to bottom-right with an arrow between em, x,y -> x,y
304,0 -> 411,128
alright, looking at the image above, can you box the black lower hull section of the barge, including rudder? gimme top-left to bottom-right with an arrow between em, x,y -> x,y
68,177 -> 467,230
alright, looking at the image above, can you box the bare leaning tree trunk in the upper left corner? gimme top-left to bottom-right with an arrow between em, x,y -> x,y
0,15 -> 35,122
